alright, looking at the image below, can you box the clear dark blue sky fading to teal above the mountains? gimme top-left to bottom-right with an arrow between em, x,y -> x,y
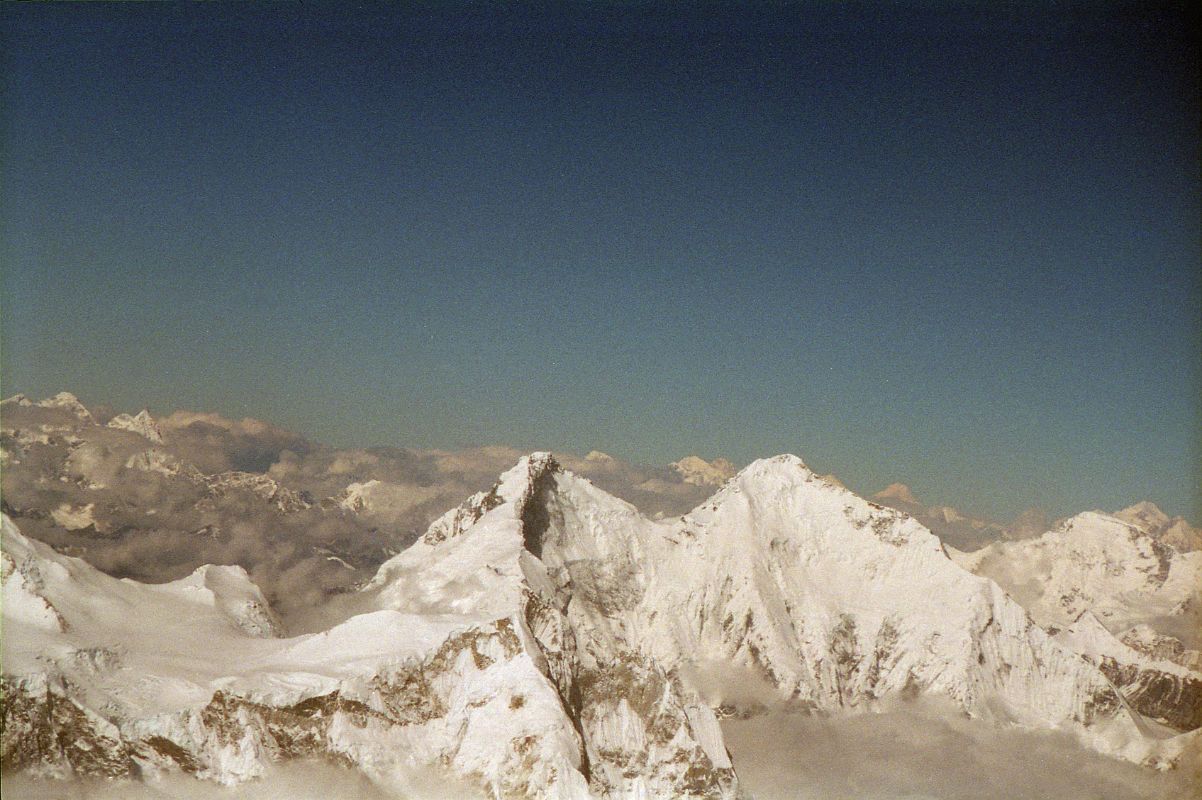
0,2 -> 1202,521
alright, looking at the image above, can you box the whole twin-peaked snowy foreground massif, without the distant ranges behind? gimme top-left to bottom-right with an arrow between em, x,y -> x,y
4,453 -> 1197,798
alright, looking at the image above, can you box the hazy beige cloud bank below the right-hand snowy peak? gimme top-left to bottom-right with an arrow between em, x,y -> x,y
722,703 -> 1202,800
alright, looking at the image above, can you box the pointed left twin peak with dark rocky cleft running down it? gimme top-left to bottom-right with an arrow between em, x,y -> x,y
364,454 -> 734,796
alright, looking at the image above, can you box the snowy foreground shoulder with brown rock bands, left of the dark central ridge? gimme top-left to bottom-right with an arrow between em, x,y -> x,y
2,518 -> 601,796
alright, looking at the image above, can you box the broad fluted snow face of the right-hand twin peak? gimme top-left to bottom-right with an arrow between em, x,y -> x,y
642,456 -> 1163,738
